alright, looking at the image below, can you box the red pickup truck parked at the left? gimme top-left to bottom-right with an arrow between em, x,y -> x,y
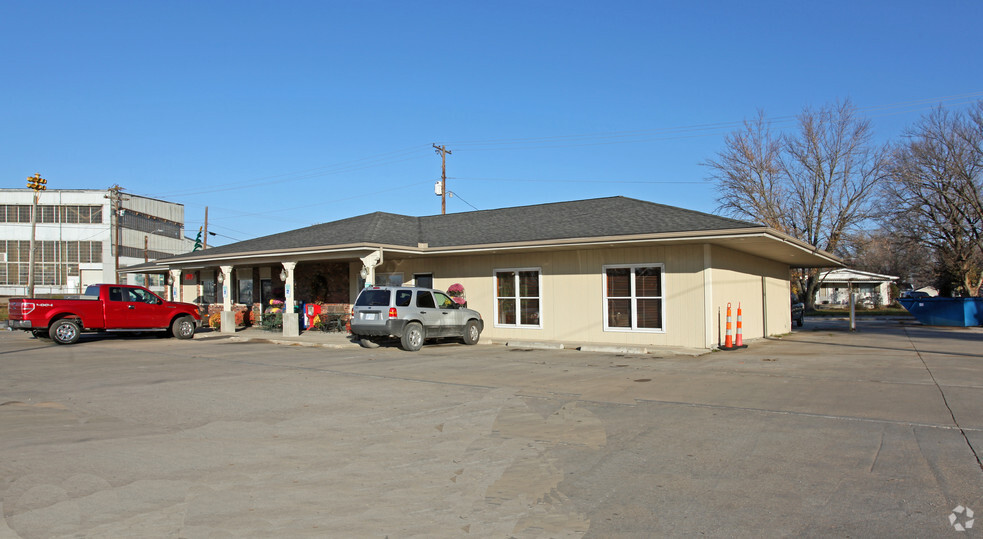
7,284 -> 201,344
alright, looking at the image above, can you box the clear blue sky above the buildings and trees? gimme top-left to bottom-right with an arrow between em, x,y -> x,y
0,0 -> 983,244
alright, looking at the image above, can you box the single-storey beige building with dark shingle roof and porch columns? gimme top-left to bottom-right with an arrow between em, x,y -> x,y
131,197 -> 842,349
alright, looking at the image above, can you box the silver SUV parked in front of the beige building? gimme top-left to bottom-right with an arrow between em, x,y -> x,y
351,286 -> 485,352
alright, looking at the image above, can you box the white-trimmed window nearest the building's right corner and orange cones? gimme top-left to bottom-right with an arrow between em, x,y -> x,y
604,264 -> 665,331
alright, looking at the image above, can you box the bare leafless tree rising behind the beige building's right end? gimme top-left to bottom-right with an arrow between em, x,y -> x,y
704,101 -> 887,309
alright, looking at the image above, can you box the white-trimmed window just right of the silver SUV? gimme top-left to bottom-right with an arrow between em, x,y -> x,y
495,268 -> 542,328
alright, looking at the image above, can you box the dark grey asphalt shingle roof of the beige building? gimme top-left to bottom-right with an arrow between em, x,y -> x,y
165,196 -> 762,258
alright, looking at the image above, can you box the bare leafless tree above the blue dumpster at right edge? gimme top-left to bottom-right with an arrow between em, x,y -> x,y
887,102 -> 983,296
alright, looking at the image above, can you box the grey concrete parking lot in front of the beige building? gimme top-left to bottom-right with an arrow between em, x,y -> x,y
0,320 -> 983,538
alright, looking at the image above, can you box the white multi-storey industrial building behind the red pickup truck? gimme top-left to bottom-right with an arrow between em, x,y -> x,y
0,189 -> 194,296
